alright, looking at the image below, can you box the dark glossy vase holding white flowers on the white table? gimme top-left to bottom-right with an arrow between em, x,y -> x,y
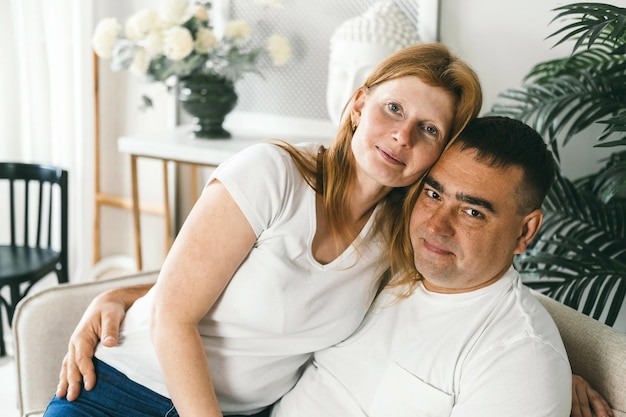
178,75 -> 237,139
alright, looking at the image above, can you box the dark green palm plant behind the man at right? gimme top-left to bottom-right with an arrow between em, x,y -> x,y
491,3 -> 626,326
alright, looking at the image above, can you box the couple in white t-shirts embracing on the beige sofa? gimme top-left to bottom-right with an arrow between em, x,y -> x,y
46,44 -> 611,417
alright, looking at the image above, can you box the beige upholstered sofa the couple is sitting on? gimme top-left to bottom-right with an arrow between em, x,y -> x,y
13,272 -> 626,417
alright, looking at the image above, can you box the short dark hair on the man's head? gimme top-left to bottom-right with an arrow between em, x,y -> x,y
454,116 -> 556,213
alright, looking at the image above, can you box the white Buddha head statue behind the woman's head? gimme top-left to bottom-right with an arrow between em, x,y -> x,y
326,0 -> 420,126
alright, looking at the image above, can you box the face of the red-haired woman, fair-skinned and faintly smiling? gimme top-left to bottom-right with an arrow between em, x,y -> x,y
351,76 -> 454,187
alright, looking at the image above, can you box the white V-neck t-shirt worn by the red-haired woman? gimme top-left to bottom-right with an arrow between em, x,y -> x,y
96,144 -> 387,413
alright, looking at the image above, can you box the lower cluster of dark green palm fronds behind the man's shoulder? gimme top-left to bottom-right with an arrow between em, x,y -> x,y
515,169 -> 626,325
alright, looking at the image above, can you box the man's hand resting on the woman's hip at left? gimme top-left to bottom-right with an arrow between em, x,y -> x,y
56,284 -> 152,401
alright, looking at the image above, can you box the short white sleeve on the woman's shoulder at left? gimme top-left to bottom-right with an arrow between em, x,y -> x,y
207,143 -> 299,237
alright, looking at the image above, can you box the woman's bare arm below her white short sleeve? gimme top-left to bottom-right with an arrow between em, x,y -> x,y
151,181 -> 256,417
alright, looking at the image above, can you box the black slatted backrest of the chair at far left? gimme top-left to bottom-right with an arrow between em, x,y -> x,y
0,162 -> 68,276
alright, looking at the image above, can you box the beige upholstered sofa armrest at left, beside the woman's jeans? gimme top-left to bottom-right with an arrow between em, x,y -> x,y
13,272 -> 158,416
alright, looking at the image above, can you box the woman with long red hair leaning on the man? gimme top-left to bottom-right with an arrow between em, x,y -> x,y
46,44 -> 482,416
